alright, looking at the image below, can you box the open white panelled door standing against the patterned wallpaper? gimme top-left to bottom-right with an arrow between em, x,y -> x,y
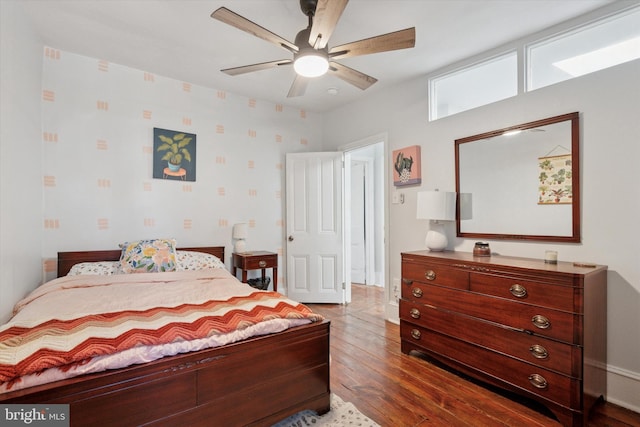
286,152 -> 347,304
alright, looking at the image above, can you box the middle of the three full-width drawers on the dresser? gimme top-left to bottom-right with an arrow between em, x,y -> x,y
400,300 -> 582,378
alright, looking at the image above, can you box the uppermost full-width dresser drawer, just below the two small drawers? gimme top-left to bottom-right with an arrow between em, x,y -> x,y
402,283 -> 582,345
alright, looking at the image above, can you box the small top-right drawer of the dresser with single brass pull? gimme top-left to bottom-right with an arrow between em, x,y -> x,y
469,273 -> 582,312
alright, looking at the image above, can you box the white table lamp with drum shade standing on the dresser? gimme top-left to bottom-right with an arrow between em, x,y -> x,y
416,190 -> 456,252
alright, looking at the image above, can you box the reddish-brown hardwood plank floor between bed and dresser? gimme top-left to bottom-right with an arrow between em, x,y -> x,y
307,285 -> 640,427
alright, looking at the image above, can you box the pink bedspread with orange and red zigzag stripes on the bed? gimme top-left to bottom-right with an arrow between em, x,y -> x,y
0,269 -> 322,392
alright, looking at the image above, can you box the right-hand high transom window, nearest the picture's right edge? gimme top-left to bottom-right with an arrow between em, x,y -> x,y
527,8 -> 640,90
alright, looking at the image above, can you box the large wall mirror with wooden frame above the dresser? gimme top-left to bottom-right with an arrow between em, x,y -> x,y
455,113 -> 580,242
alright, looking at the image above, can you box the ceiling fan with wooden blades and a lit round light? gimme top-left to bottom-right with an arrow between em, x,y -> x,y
211,0 -> 416,98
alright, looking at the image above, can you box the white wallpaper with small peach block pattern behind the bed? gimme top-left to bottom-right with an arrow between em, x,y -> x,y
42,48 -> 322,285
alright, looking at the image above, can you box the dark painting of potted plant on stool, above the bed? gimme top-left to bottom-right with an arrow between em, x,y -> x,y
153,128 -> 196,181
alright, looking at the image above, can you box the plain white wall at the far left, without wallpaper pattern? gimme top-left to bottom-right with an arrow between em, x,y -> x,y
0,1 -> 42,322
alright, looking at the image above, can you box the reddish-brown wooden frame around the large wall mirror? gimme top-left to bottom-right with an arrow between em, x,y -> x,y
455,112 -> 581,243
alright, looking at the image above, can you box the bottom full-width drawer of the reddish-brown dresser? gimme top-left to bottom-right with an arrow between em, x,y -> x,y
400,322 -> 582,408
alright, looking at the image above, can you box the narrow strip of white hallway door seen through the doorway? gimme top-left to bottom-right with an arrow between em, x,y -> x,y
347,160 -> 367,284
